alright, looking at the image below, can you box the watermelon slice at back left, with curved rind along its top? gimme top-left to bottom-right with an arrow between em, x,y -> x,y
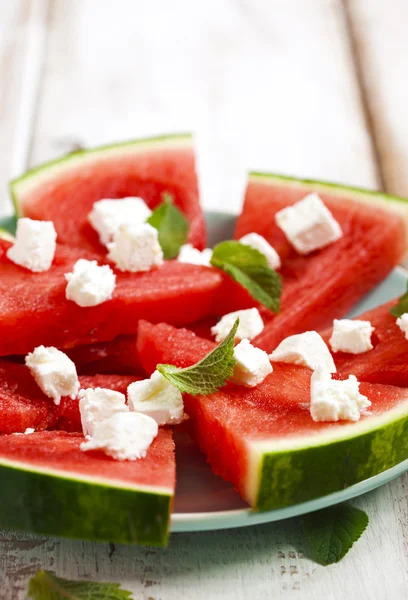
11,135 -> 206,254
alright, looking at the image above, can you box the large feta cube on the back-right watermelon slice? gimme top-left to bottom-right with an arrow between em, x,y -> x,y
275,194 -> 343,254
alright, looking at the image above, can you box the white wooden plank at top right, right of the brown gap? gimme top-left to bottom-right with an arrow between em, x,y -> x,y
347,0 -> 408,196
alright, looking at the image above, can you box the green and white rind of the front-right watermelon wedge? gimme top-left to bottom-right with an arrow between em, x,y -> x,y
246,398 -> 408,511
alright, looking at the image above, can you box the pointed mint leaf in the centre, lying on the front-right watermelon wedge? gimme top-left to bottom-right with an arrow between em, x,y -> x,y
156,319 -> 239,396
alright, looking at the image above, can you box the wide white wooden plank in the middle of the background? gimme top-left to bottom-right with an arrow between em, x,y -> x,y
31,0 -> 378,216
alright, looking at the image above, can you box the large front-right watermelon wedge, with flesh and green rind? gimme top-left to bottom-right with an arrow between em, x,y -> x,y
138,323 -> 408,510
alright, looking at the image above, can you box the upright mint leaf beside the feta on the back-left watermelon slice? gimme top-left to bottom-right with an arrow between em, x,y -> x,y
147,193 -> 188,260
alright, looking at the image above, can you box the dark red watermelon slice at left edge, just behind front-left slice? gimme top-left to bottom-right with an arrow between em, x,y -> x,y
0,360 -> 137,434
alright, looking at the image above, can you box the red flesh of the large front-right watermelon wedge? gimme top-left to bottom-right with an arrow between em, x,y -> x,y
138,323 -> 408,507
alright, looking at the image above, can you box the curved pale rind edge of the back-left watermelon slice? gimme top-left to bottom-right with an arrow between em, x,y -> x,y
10,133 -> 193,218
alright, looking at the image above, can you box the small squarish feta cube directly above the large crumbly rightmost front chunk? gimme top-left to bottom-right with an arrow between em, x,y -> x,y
329,319 -> 374,354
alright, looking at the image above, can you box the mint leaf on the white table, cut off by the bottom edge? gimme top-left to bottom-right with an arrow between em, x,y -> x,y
28,569 -> 133,600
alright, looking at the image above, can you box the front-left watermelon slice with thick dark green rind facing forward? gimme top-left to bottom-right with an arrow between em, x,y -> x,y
0,428 -> 175,546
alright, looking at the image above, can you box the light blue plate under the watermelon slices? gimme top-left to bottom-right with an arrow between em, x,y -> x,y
0,213 -> 408,532
